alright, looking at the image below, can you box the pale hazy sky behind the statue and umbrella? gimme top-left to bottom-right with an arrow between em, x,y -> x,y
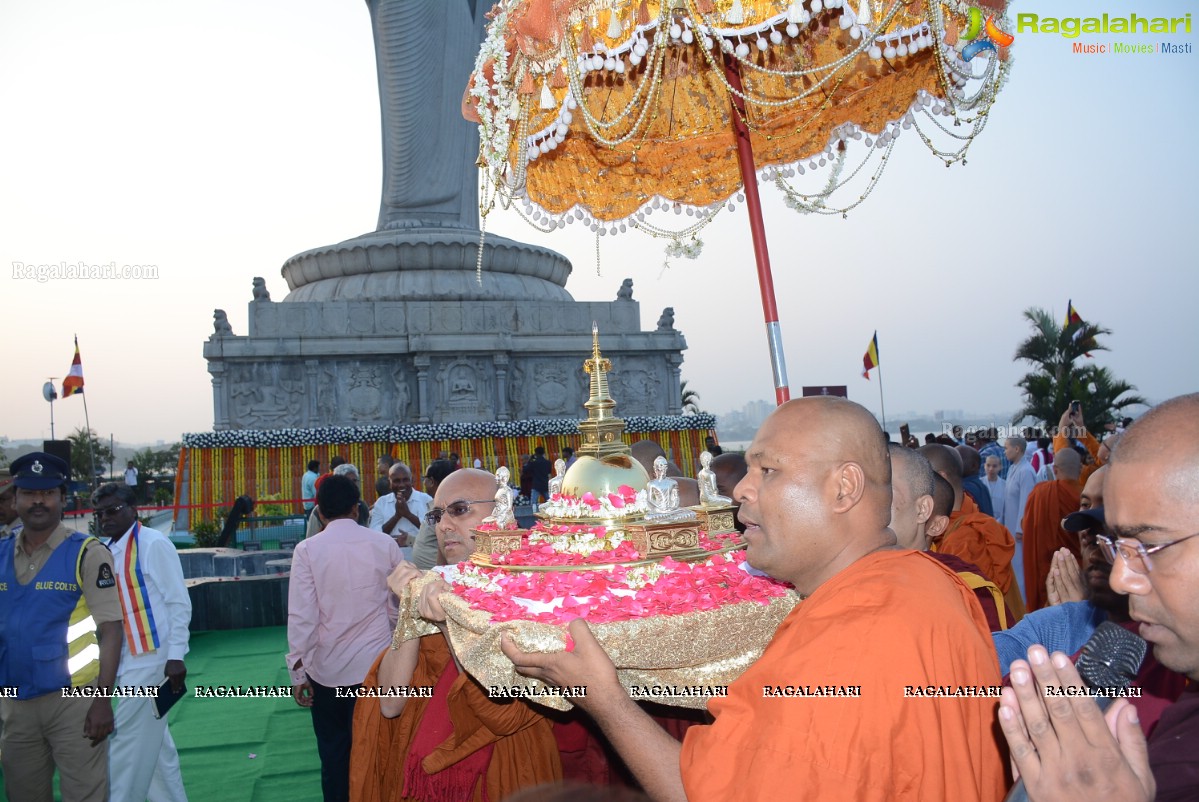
0,0 -> 1199,442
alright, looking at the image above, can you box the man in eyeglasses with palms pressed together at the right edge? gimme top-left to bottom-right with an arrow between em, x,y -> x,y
1000,393 -> 1199,802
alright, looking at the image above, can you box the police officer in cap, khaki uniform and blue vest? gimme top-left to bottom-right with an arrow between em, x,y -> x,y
0,452 -> 122,802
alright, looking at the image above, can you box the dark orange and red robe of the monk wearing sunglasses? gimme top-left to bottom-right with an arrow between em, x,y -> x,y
350,634 -> 562,802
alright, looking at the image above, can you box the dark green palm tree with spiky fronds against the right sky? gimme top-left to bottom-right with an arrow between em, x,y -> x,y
1012,307 -> 1145,432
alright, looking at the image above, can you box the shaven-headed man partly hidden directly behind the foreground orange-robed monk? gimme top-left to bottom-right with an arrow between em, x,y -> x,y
887,442 -> 1011,632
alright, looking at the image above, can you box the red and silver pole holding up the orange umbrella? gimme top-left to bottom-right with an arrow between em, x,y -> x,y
721,53 -> 791,404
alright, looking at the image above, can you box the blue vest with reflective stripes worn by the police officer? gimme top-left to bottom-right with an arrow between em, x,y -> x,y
0,532 -> 100,699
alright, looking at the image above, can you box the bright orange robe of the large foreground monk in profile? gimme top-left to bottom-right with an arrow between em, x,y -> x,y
680,549 -> 1005,802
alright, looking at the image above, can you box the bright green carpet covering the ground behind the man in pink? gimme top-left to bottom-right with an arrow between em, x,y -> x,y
0,627 -> 321,802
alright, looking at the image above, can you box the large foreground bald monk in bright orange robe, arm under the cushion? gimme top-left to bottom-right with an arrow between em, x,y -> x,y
501,397 -> 1005,802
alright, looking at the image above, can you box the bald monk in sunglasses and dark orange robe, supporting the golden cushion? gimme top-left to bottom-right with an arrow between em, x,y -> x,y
350,468 -> 562,802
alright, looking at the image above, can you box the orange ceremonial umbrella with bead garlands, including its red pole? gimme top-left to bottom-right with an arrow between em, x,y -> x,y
464,0 -> 1012,403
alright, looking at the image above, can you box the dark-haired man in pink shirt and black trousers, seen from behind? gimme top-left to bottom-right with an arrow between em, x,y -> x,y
287,476 -> 402,802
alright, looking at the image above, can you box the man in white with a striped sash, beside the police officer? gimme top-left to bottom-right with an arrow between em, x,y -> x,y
92,483 -> 192,802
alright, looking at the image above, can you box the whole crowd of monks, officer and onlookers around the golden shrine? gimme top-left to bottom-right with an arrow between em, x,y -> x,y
0,394 -> 1199,802
